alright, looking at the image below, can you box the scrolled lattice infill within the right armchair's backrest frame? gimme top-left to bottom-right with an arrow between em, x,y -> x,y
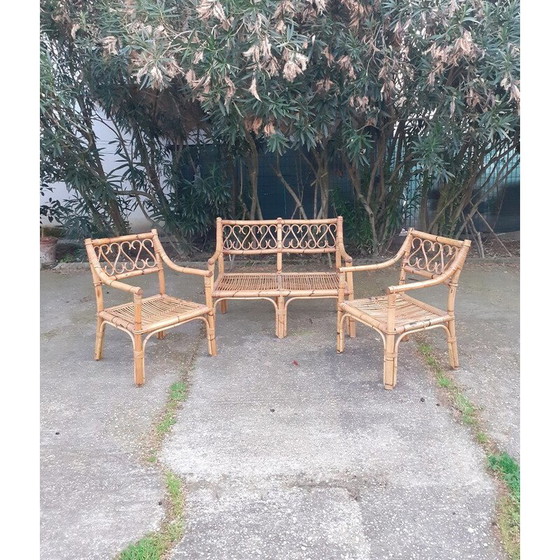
402,235 -> 463,278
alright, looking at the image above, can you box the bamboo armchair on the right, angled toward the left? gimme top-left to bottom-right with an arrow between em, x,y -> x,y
337,228 -> 471,389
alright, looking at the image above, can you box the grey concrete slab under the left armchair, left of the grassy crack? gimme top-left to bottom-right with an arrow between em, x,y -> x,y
40,269 -> 208,560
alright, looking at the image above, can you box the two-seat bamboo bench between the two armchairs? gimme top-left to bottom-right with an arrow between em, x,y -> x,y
208,217 -> 355,338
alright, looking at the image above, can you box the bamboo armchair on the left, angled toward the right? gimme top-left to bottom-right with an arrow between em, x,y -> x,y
85,229 -> 216,386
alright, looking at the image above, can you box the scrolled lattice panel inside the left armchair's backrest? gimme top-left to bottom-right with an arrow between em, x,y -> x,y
93,238 -> 158,280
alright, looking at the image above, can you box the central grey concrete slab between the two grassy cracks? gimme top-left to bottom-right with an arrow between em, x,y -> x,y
162,260 -> 518,560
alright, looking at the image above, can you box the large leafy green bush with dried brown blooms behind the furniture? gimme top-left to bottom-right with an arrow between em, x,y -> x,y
41,0 -> 519,253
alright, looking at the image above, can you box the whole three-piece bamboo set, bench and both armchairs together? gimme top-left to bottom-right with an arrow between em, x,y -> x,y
85,217 -> 470,389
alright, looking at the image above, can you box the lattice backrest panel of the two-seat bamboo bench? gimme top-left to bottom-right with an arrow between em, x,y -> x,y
222,221 -> 337,255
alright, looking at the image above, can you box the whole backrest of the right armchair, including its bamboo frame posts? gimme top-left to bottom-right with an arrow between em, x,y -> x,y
399,228 -> 471,284
